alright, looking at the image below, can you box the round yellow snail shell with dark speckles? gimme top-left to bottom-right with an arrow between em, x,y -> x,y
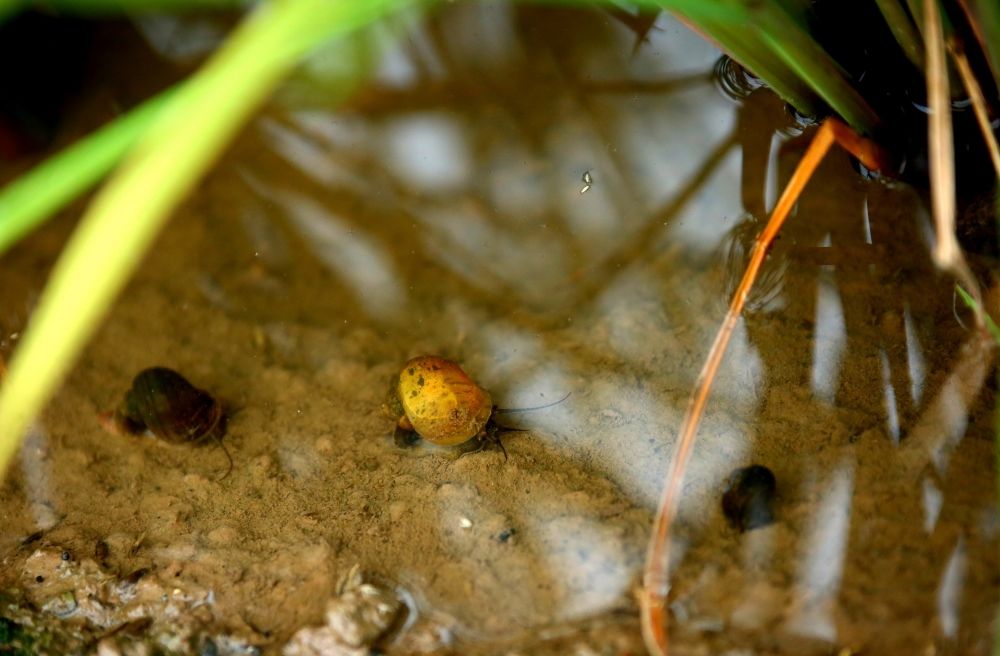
388,355 -> 493,446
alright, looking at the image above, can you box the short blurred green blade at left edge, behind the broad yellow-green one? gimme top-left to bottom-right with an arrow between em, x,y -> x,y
0,92 -> 169,255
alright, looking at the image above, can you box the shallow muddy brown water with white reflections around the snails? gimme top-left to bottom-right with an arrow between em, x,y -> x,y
0,3 -> 1000,654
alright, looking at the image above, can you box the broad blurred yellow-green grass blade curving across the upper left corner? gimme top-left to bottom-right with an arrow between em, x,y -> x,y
0,0 -> 418,472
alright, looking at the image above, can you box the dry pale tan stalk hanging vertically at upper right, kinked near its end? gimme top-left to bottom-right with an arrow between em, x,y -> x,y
924,0 -> 983,326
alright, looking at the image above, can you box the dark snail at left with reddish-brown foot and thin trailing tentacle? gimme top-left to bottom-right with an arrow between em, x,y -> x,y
100,367 -> 233,480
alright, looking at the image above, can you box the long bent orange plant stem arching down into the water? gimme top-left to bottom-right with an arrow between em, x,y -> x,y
639,118 -> 888,656
